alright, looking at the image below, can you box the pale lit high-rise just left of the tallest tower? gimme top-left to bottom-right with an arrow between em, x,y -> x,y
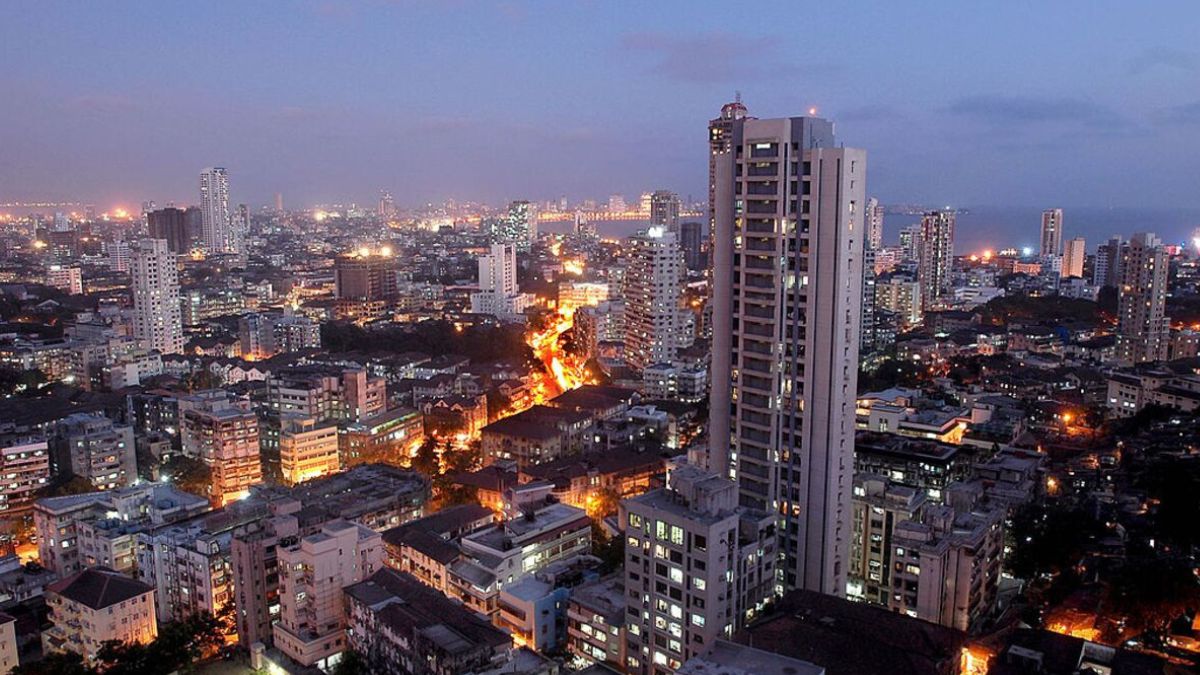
625,227 -> 683,370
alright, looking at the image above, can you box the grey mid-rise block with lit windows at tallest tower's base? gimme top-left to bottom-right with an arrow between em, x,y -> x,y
619,465 -> 778,675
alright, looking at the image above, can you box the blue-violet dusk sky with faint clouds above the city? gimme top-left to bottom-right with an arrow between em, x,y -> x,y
0,0 -> 1200,208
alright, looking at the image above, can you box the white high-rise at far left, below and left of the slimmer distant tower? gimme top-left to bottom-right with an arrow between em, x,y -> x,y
130,239 -> 184,354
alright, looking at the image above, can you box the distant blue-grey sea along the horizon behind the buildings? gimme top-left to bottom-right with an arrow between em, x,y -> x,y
541,207 -> 1200,253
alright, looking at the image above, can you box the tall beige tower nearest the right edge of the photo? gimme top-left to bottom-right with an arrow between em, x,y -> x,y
1117,232 -> 1171,365
